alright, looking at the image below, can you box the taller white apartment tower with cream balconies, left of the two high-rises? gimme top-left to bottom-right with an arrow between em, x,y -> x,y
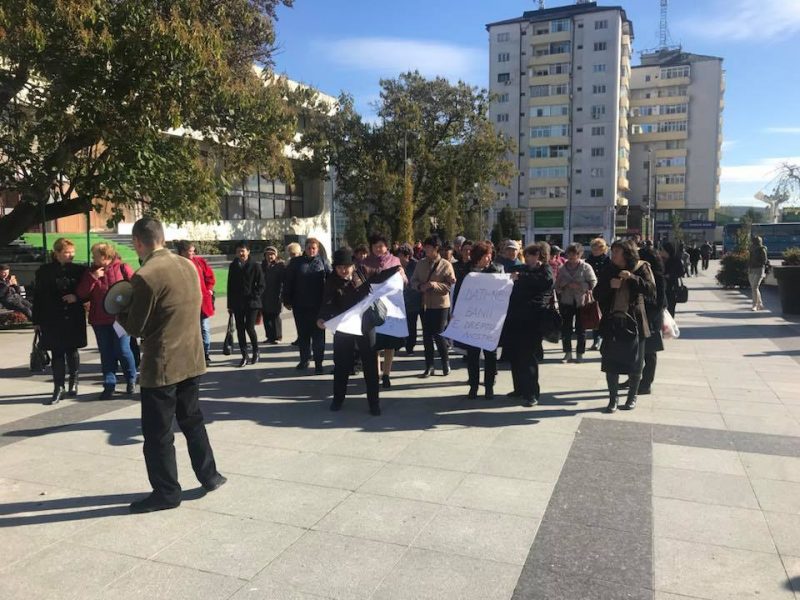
486,2 -> 633,246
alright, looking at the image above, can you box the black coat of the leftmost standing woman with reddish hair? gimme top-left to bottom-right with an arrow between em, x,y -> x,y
32,261 -> 86,352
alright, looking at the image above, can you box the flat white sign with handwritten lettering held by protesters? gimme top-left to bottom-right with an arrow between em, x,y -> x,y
442,273 -> 514,351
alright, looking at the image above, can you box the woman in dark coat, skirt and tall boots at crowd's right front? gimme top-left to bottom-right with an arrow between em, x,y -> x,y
595,241 -> 656,413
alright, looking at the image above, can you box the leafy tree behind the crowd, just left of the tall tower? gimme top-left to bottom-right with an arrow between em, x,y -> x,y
301,72 -> 515,244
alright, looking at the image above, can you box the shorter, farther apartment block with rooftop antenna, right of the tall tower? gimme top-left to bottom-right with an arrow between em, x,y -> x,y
628,48 -> 725,241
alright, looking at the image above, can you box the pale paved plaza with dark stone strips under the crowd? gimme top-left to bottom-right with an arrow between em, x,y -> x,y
0,265 -> 800,600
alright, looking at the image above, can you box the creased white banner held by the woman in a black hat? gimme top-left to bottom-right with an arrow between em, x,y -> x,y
325,273 -> 408,338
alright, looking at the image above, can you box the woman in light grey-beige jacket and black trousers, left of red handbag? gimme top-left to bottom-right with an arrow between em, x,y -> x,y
555,244 -> 597,363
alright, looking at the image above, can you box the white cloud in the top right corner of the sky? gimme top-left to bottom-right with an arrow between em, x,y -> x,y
678,0 -> 800,41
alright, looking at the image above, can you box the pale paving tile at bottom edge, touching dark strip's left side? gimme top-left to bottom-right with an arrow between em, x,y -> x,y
372,548 -> 520,600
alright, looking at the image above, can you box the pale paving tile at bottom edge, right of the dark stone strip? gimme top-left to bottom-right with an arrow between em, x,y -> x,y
654,537 -> 794,600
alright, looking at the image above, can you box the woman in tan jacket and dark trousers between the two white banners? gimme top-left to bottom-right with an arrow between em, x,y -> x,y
410,236 -> 456,378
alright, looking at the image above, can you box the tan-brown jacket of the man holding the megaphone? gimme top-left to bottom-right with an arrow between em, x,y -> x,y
117,248 -> 206,388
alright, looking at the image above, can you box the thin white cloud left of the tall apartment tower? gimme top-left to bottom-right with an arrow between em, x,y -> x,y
320,37 -> 488,85
